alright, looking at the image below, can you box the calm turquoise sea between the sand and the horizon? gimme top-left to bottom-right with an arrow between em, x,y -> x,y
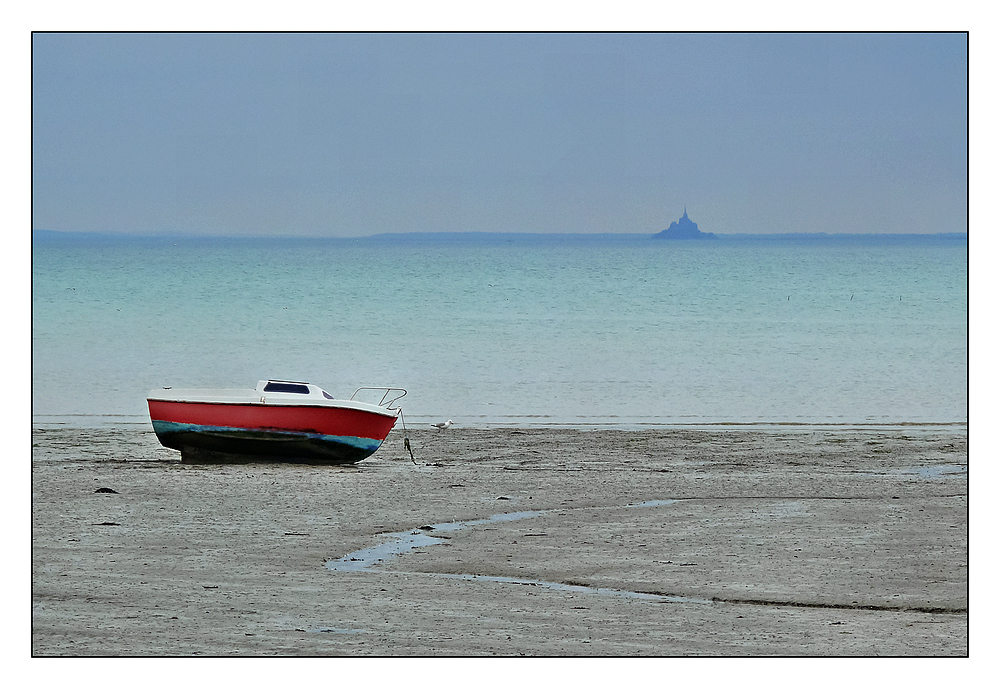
31,232 -> 969,429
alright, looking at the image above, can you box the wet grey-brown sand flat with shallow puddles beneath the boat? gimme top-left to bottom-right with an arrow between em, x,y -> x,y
31,426 -> 968,656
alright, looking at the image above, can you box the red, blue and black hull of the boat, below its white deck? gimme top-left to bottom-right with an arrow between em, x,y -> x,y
148,399 -> 397,464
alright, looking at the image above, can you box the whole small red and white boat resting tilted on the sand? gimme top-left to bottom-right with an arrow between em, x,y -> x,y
146,380 -> 406,464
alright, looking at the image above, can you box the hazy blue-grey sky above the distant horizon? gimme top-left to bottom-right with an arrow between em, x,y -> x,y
32,33 -> 968,236
